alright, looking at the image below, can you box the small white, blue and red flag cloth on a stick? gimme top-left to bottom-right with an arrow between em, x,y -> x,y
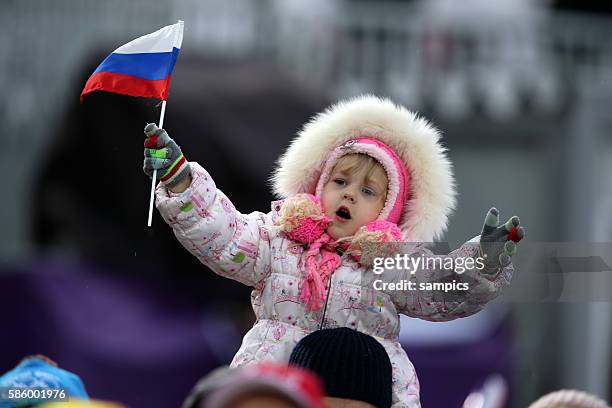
80,20 -> 183,102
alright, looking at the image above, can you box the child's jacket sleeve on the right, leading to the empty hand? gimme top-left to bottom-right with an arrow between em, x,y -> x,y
381,236 -> 514,321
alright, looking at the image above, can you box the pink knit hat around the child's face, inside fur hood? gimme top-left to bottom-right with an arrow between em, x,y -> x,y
315,137 -> 410,224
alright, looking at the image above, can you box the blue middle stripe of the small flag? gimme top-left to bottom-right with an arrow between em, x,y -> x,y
94,47 -> 180,80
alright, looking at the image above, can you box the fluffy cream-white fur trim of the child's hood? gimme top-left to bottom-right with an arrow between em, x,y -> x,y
271,95 -> 456,242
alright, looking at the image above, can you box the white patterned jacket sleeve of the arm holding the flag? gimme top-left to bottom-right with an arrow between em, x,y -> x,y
156,162 -> 272,286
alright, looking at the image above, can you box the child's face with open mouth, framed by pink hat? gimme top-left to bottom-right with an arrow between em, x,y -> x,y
321,155 -> 388,240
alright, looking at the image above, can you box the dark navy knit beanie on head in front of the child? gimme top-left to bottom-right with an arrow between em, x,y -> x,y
289,327 -> 392,408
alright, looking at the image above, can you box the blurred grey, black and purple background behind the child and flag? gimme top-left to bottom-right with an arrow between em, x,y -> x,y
0,0 -> 612,407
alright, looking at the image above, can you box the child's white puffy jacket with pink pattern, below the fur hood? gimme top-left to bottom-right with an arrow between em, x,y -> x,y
156,162 -> 512,407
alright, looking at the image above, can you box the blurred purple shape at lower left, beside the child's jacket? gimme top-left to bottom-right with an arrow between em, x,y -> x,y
0,262 -> 239,408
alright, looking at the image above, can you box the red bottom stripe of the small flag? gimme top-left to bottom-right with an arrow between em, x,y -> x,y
80,72 -> 170,103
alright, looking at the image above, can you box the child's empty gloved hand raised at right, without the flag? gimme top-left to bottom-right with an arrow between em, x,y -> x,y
480,207 -> 525,270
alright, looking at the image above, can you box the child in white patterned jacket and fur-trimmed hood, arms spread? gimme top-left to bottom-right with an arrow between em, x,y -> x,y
144,96 -> 524,407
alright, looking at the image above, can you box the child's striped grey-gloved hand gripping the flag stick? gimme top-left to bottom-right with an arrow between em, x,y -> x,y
142,123 -> 191,192
